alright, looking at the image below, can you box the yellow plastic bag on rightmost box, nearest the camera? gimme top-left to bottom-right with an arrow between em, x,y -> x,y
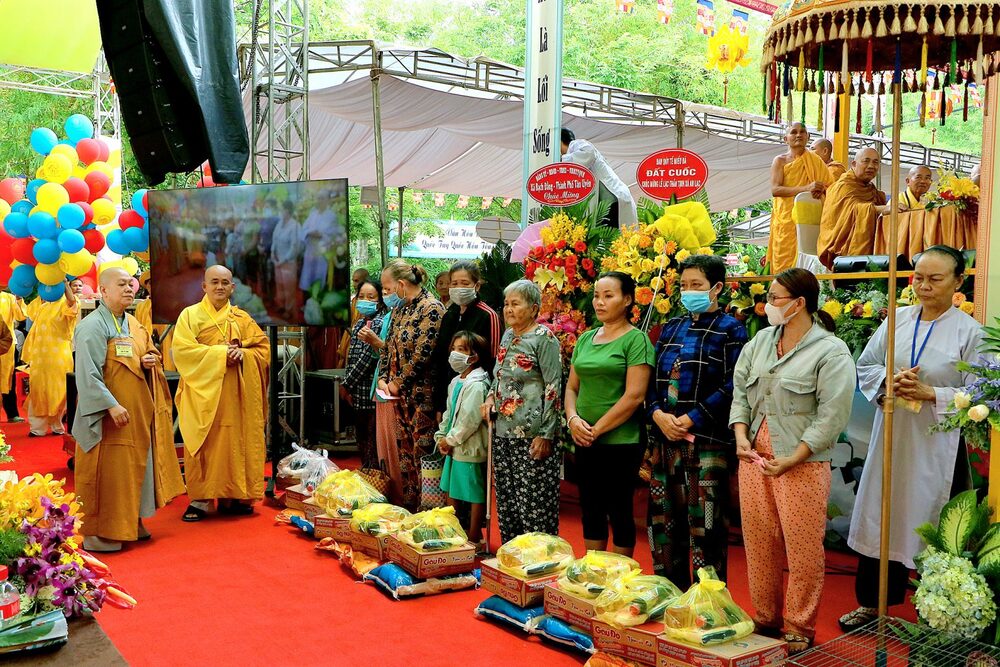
663,567 -> 753,646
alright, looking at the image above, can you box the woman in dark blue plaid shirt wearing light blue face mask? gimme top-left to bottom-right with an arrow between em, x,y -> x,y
646,255 -> 747,590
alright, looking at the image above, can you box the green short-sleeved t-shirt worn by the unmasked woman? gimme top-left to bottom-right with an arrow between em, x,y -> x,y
572,329 -> 655,445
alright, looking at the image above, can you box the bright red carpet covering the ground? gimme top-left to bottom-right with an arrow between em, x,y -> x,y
3,424 -> 913,667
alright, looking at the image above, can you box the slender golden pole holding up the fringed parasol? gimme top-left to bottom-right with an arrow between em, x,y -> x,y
878,75 -> 903,616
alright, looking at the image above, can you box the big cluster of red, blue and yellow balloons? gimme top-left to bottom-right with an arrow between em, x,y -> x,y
0,114 -> 119,301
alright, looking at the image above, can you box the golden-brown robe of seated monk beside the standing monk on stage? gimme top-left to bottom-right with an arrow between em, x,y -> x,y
816,171 -> 886,267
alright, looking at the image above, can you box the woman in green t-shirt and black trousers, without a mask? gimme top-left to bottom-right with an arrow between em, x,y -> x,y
566,271 -> 654,556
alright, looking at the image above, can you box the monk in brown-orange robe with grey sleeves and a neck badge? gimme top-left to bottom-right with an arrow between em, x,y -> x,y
73,268 -> 184,552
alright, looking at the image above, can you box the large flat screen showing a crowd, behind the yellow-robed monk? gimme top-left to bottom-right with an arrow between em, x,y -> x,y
149,179 -> 351,327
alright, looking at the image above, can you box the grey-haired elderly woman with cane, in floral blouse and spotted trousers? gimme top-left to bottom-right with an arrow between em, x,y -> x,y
483,280 -> 562,542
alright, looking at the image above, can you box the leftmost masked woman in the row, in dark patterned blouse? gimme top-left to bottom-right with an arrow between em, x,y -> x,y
340,280 -> 387,468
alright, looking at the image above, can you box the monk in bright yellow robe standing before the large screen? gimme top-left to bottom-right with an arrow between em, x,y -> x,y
172,266 -> 270,521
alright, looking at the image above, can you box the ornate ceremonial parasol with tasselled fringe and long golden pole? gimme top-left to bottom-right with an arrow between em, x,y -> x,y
761,0 -> 1000,615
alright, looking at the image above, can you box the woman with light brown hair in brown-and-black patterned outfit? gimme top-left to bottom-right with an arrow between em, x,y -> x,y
379,259 -> 444,510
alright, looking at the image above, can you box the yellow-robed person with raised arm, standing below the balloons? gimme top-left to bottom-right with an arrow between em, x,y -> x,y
21,280 -> 83,437
